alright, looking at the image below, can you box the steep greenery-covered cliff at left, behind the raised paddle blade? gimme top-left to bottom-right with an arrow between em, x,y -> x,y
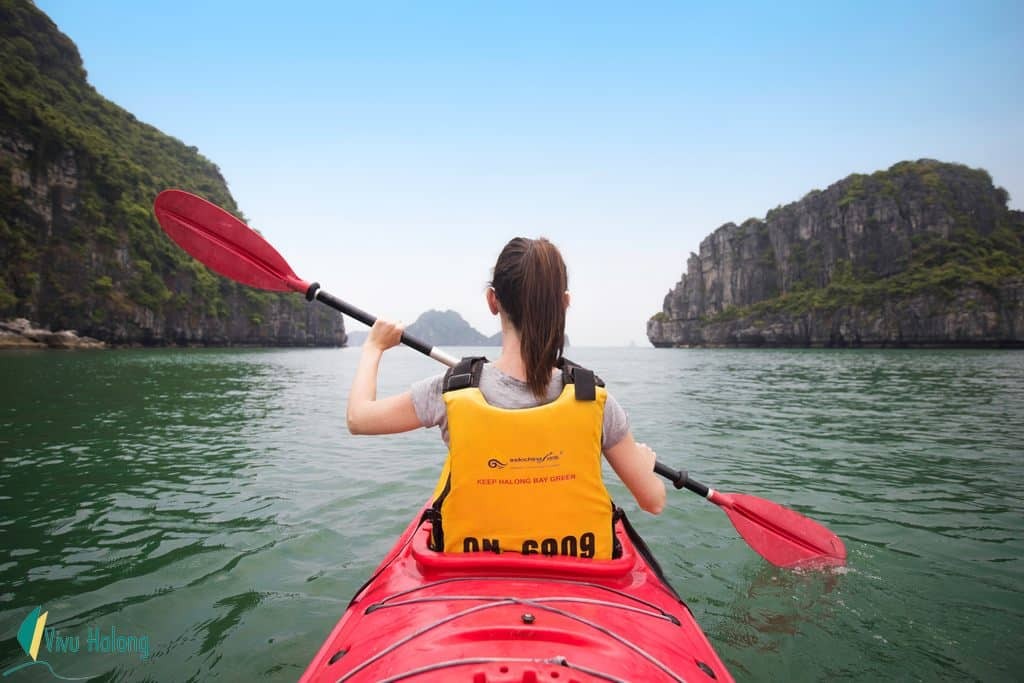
0,0 -> 345,346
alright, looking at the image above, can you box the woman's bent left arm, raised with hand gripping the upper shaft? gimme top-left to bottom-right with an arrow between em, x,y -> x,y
345,318 -> 422,434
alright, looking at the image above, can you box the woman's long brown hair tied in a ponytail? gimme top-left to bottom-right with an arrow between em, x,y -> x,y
490,238 -> 568,398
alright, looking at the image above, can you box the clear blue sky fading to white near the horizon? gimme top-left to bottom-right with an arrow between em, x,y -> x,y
37,0 -> 1024,345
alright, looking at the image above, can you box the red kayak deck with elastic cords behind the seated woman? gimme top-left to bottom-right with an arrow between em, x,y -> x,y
300,507 -> 733,683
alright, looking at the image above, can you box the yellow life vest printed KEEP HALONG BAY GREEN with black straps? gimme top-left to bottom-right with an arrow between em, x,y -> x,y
432,358 -> 615,559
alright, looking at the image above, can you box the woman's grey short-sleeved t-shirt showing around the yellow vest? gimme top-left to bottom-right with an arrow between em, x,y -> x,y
412,362 -> 630,451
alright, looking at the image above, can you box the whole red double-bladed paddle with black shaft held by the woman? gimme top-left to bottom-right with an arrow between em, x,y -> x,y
153,189 -> 846,567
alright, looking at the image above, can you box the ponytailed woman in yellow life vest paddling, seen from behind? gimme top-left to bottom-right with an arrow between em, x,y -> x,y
346,238 -> 666,559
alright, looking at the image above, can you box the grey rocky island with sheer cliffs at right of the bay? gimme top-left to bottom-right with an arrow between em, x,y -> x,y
647,160 -> 1024,346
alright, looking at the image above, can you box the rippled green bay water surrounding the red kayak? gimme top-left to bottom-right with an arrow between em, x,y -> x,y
0,348 -> 1024,682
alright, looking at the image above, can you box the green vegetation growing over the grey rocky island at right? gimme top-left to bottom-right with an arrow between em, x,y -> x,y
692,160 -> 1024,323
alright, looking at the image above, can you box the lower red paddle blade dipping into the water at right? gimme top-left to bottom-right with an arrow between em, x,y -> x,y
710,492 -> 846,568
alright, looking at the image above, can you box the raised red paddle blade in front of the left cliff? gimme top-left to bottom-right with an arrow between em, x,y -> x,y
153,189 -> 309,294
